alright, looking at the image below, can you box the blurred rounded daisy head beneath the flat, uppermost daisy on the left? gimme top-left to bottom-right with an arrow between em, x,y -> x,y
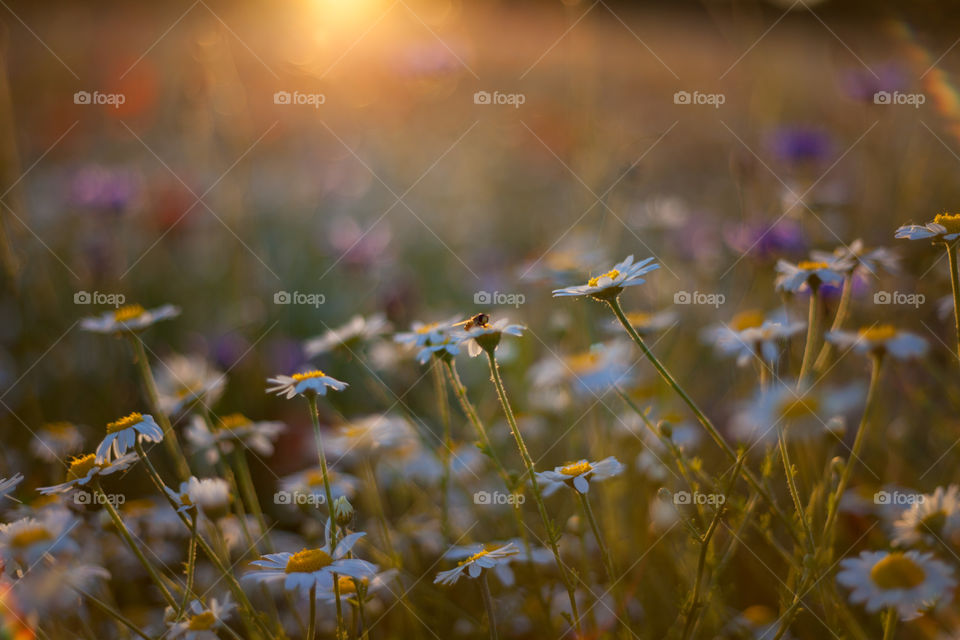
153,355 -> 227,415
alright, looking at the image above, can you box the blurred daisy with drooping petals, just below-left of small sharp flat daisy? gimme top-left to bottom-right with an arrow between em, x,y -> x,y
184,413 -> 287,464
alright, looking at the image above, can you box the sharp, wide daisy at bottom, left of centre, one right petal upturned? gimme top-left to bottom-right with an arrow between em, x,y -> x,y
245,531 -> 377,595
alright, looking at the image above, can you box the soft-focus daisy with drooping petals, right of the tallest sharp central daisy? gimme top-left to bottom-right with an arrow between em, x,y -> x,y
703,310 -> 807,367
